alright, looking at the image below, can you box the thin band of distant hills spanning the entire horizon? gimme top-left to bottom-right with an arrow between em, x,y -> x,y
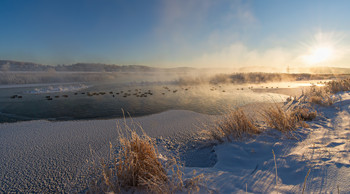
0,60 -> 350,74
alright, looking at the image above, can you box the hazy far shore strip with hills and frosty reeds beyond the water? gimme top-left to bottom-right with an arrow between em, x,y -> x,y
0,60 -> 350,85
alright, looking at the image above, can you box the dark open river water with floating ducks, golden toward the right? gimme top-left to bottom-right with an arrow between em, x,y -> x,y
0,83 -> 286,122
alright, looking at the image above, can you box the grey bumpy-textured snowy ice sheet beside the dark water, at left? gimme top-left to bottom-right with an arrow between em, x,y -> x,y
0,110 -> 211,193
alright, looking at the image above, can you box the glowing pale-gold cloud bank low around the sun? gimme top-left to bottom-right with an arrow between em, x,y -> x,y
159,32 -> 350,69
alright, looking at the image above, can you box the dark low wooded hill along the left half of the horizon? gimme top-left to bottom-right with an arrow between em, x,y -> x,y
0,60 -> 194,72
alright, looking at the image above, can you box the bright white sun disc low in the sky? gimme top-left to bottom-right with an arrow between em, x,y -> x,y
303,46 -> 334,65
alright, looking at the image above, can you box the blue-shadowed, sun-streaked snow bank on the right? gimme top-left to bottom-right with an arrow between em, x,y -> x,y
186,92 -> 350,193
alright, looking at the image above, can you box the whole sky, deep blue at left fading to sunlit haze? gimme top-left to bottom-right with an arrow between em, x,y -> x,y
0,0 -> 350,68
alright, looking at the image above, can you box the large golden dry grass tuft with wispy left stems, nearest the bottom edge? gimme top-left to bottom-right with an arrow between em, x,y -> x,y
90,132 -> 168,193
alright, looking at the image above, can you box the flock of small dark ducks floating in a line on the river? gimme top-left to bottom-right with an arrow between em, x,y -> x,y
10,85 -> 284,100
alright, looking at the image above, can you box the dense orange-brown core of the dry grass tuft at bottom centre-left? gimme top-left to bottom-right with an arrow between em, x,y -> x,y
115,132 -> 168,190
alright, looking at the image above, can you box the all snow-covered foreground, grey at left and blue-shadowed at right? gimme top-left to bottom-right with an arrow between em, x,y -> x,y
0,93 -> 350,193
